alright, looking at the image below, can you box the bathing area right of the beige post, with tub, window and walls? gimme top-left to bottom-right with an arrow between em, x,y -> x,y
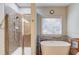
37,4 -> 79,55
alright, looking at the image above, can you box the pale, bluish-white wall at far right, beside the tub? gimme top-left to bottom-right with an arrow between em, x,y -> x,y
67,4 -> 79,38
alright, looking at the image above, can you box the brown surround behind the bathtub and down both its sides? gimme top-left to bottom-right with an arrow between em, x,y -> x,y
37,35 -> 79,55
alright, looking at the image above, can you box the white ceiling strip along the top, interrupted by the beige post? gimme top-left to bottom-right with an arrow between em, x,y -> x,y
16,3 -> 70,8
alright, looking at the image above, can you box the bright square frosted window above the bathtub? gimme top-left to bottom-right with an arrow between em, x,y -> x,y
42,17 -> 62,34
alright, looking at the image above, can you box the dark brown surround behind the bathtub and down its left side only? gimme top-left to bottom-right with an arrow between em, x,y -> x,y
37,35 -> 70,55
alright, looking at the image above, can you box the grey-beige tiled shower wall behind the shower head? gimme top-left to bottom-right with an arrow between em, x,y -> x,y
8,14 -> 22,54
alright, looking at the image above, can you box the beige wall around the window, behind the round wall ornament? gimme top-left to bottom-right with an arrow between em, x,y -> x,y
37,7 -> 67,35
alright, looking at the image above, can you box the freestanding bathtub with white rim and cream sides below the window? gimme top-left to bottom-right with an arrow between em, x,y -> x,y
41,41 -> 71,55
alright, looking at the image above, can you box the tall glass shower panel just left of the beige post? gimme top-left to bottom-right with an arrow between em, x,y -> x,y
22,14 -> 31,55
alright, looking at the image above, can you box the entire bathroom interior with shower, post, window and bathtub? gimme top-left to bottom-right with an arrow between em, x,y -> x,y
0,3 -> 79,55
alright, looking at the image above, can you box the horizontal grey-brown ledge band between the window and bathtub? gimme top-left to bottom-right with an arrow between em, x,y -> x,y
40,35 -> 68,41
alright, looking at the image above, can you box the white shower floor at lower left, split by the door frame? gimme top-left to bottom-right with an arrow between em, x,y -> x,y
12,47 -> 31,55
